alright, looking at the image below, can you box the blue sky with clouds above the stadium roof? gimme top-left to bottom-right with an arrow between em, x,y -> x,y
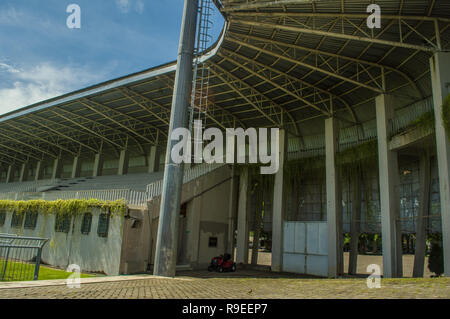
0,0 -> 223,114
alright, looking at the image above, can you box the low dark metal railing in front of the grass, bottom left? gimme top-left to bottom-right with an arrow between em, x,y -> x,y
0,234 -> 48,281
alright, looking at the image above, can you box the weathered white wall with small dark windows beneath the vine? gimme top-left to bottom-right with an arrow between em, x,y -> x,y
0,209 -> 124,275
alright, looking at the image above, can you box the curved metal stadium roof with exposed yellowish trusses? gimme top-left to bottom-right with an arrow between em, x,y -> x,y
0,0 -> 450,165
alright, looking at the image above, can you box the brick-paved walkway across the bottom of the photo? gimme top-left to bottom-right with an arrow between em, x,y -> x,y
0,270 -> 450,299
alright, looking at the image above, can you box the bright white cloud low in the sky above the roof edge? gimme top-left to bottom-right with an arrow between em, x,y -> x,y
0,63 -> 103,114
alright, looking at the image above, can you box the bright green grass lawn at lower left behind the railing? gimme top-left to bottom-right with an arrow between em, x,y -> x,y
0,260 -> 95,282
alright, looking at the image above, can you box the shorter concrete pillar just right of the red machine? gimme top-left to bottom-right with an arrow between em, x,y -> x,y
236,167 -> 250,264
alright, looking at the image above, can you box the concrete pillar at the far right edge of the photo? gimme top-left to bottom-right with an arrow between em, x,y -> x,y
430,52 -> 450,277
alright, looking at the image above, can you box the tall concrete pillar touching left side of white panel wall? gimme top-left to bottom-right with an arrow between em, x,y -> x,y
271,130 -> 287,272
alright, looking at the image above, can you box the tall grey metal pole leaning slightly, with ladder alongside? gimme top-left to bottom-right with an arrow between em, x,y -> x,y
153,0 -> 198,277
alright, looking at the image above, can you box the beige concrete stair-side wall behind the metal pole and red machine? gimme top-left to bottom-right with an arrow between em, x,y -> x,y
149,166 -> 231,269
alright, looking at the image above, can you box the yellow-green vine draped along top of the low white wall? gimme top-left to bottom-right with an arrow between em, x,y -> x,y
0,199 -> 127,216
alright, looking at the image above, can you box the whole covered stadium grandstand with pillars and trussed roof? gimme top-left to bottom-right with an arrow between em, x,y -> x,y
0,0 -> 450,277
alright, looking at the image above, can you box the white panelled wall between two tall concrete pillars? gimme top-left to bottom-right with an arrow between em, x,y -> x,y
283,222 -> 328,277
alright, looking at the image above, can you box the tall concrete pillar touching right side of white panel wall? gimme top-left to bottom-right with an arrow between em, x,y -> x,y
325,118 -> 344,277
